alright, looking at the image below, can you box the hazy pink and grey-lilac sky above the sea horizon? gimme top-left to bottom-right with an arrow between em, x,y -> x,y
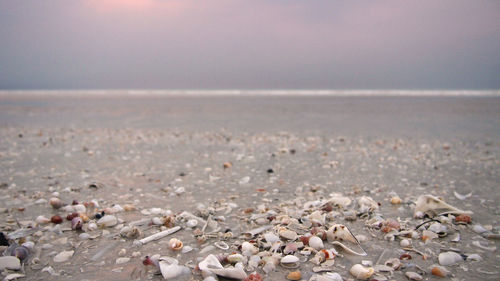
0,0 -> 500,90
